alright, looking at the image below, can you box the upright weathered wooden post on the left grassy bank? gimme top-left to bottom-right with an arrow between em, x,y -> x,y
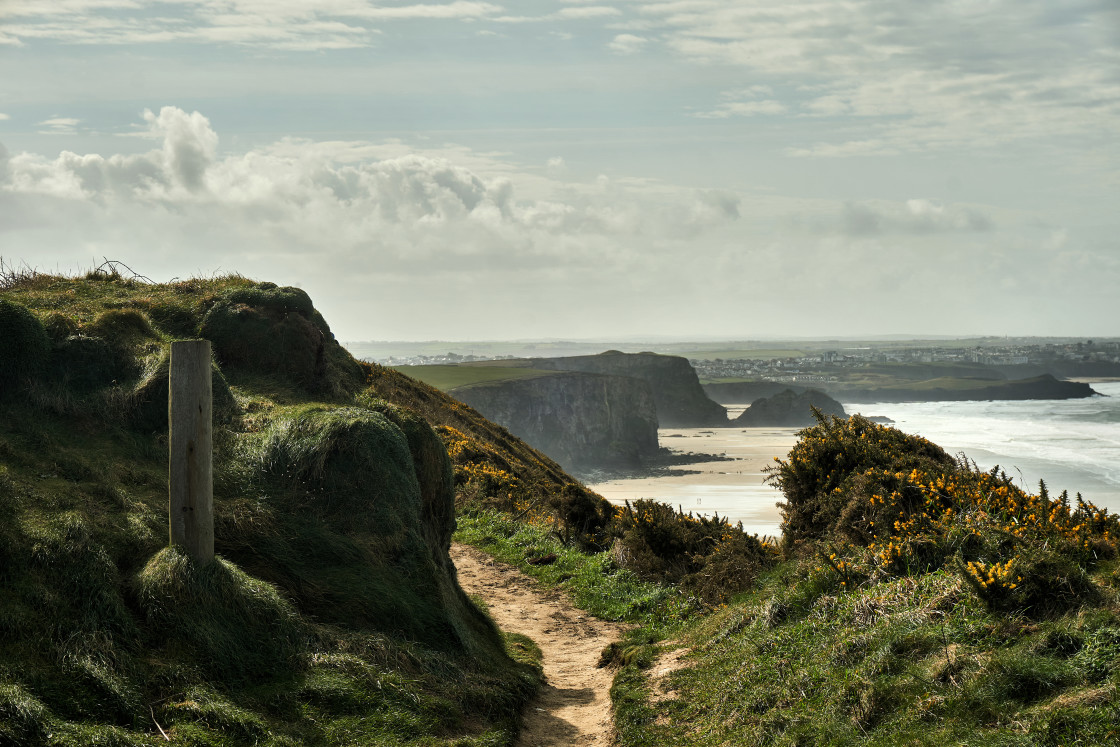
167,339 -> 214,563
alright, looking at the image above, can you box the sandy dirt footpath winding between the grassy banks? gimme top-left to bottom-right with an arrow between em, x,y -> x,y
451,544 -> 625,747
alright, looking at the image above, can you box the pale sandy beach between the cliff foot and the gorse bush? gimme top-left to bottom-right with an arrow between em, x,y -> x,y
588,409 -> 799,536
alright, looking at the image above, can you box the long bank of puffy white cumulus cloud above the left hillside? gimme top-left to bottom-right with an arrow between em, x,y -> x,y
0,106 -> 752,335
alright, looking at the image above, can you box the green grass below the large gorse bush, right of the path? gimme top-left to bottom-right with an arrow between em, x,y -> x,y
625,568 -> 1120,745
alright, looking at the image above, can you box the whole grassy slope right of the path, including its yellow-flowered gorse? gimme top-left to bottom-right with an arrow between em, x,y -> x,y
616,417 -> 1120,746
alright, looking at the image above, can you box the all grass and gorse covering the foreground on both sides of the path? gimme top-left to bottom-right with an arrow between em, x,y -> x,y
0,265 -> 1120,747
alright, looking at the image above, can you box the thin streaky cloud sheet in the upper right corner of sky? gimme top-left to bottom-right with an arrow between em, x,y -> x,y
636,0 -> 1120,157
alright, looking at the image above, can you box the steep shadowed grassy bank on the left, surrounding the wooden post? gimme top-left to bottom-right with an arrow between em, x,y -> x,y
0,271 -> 544,746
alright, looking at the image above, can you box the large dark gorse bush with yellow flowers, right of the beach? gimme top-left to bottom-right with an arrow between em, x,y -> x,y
769,415 -> 1120,616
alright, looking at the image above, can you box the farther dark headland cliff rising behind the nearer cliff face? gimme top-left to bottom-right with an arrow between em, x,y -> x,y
531,351 -> 727,428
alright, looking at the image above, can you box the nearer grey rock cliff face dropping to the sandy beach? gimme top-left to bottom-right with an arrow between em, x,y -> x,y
449,372 -> 657,469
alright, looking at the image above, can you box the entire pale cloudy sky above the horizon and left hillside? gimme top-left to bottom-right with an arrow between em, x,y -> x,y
0,0 -> 1120,340
